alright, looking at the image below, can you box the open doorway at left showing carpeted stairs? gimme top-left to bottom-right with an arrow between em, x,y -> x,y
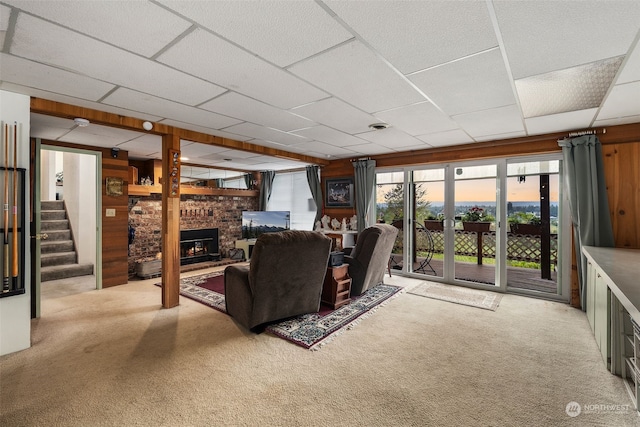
32,141 -> 102,317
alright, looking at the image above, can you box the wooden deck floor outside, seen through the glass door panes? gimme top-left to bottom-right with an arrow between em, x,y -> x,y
392,255 -> 557,294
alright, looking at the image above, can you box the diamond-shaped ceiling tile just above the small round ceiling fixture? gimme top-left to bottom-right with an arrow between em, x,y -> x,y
289,41 -> 425,113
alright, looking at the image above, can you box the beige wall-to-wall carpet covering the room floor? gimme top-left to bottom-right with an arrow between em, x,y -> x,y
0,276 -> 638,427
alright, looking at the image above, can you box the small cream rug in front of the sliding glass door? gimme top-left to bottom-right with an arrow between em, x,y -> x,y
407,282 -> 502,311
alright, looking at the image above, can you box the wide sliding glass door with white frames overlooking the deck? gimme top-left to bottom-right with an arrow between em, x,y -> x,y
376,156 -> 570,299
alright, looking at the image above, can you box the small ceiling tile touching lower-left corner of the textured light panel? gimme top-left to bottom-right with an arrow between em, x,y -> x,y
453,105 -> 524,139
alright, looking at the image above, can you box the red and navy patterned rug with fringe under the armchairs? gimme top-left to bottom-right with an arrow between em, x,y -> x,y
157,272 -> 402,350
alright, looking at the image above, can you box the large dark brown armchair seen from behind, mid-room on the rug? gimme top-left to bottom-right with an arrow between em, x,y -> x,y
224,230 -> 331,330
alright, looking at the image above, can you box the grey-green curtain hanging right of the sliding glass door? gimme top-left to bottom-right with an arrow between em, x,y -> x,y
558,135 -> 614,311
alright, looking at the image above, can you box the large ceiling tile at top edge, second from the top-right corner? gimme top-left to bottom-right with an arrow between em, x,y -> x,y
325,1 -> 498,74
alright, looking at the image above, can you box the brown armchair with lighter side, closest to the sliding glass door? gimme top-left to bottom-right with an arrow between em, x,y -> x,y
344,224 -> 398,296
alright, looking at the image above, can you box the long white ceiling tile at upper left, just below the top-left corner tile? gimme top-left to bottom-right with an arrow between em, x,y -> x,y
10,13 -> 225,105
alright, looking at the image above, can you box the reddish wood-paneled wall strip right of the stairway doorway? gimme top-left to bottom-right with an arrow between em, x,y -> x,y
42,140 -> 129,288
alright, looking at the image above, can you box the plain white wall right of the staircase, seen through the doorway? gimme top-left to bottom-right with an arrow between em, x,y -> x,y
63,152 -> 97,265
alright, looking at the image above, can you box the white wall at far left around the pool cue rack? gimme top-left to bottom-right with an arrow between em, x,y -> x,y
0,90 -> 31,355
